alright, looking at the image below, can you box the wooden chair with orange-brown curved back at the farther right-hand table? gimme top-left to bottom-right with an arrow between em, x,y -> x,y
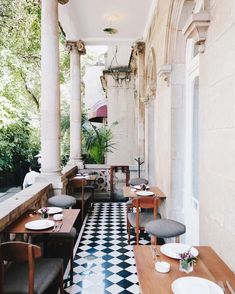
127,196 -> 158,244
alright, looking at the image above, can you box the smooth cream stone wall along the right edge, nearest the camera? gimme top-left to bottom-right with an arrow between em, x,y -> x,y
200,0 -> 235,270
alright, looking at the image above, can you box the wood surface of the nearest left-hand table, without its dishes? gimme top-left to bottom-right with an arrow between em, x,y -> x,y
4,209 -> 80,234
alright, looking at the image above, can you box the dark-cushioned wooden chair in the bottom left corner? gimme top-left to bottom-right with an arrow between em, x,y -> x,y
0,241 -> 64,294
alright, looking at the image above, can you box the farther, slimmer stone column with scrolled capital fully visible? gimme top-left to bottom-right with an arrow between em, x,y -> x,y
66,41 -> 86,168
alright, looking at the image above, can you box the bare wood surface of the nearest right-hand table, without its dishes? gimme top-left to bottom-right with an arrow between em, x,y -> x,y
134,245 -> 235,294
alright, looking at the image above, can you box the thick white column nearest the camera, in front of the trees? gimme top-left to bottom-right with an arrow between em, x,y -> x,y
41,0 -> 61,175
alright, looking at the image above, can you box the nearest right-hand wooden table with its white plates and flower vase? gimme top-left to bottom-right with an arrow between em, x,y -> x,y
134,243 -> 235,294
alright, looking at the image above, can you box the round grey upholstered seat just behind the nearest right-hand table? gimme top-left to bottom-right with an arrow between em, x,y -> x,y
145,219 -> 186,242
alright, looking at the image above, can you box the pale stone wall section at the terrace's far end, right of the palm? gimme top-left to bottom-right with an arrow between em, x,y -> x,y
105,73 -> 138,165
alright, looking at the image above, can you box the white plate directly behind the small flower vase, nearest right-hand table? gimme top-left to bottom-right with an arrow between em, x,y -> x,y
160,243 -> 198,259
